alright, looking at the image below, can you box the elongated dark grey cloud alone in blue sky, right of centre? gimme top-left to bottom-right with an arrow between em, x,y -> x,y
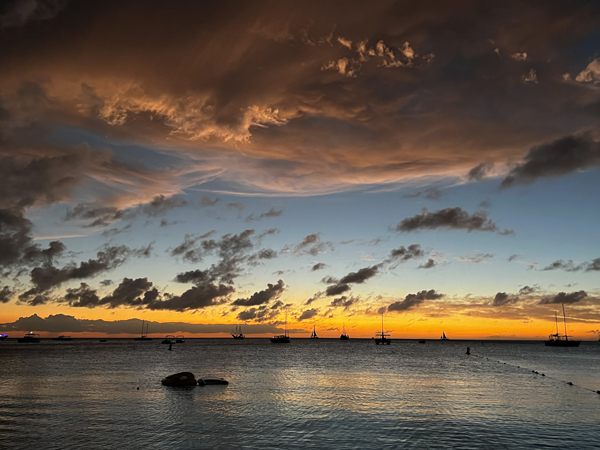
396,207 -> 514,234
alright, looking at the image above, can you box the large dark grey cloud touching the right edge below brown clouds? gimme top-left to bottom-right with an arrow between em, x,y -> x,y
500,135 -> 600,189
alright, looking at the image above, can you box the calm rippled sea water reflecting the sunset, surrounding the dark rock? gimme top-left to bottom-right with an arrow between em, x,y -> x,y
0,339 -> 600,449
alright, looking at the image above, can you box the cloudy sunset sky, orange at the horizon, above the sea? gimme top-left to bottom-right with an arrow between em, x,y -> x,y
0,0 -> 600,340
